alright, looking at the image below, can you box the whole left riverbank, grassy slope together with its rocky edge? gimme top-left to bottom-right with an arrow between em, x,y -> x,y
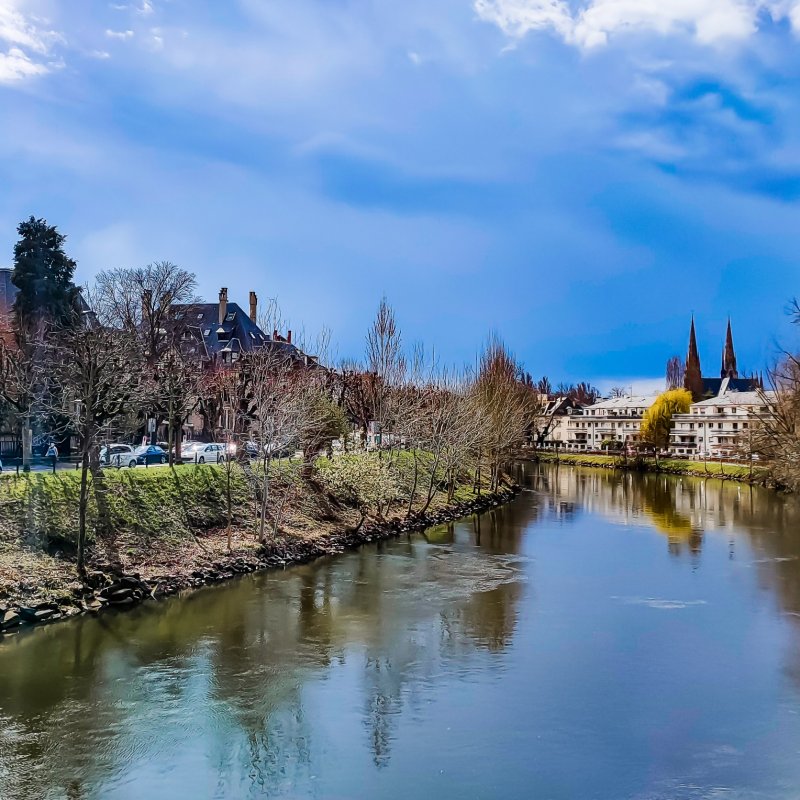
0,465 -> 517,635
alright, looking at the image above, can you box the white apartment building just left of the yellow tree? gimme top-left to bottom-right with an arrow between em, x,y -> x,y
566,395 -> 656,451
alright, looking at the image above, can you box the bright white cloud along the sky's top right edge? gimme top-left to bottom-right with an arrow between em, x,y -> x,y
474,0 -> 800,49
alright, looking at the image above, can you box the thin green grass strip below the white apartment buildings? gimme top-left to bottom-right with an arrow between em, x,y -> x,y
536,453 -> 770,486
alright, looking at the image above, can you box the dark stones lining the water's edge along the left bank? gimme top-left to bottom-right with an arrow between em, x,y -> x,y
0,486 -> 519,637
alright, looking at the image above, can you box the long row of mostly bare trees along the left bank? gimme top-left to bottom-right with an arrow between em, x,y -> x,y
0,218 -> 542,572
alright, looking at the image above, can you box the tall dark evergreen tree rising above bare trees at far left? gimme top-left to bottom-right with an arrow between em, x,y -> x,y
11,217 -> 78,329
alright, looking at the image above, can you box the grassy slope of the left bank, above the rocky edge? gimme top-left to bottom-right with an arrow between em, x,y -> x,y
0,453 -> 510,616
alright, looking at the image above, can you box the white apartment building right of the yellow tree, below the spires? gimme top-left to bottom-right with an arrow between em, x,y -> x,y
669,378 -> 775,458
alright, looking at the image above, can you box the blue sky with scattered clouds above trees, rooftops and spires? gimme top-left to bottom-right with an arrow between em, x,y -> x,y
0,0 -> 800,391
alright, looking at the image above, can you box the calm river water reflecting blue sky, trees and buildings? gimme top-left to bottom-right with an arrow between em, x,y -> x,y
0,466 -> 800,800
